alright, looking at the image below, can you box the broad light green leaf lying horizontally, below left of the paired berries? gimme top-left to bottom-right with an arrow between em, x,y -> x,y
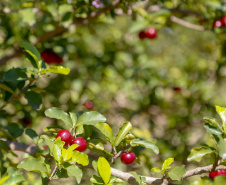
17,158 -> 48,176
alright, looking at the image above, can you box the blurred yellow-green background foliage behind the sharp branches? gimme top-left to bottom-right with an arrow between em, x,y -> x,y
0,0 -> 226,184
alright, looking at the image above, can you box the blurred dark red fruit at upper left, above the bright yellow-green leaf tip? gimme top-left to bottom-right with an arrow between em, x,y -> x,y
41,50 -> 63,64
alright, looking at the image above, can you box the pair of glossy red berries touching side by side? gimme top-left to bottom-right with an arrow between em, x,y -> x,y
56,129 -> 87,152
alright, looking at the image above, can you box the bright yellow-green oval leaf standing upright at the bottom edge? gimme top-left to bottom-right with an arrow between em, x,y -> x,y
98,157 -> 111,184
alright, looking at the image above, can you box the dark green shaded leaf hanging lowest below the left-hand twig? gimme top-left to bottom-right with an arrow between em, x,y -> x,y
24,91 -> 42,109
